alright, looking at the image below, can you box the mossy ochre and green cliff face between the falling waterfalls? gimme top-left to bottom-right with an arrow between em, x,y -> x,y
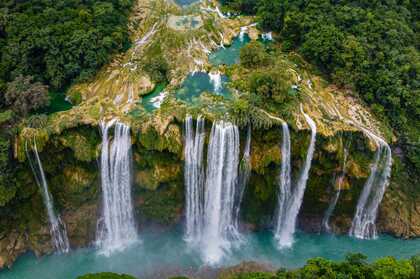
0,110 -> 420,267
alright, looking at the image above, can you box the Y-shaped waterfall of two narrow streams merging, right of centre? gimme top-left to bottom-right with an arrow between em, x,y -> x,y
275,110 -> 316,248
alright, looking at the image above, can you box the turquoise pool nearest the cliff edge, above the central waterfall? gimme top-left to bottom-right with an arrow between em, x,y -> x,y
176,72 -> 230,103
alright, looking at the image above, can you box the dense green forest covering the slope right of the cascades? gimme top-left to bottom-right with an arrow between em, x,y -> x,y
222,0 -> 420,174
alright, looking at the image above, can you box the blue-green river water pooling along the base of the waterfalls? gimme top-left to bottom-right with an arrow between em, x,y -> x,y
0,231 -> 420,279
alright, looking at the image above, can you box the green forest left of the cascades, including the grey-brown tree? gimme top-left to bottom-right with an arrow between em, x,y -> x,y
0,0 -> 133,205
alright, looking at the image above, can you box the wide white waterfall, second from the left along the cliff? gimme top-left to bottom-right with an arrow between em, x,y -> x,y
97,120 -> 137,254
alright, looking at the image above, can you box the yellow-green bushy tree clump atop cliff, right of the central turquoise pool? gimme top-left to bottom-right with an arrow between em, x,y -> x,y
229,41 -> 300,128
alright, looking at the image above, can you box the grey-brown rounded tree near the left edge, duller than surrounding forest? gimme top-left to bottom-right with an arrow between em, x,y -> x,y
5,76 -> 49,117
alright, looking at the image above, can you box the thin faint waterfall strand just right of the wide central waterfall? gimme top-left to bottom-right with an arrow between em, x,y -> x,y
233,126 -> 251,230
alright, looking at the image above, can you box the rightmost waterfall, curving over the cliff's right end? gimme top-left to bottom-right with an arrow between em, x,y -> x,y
349,132 -> 392,239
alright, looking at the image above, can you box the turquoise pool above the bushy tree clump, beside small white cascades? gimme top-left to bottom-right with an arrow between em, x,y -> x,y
209,34 -> 251,66
